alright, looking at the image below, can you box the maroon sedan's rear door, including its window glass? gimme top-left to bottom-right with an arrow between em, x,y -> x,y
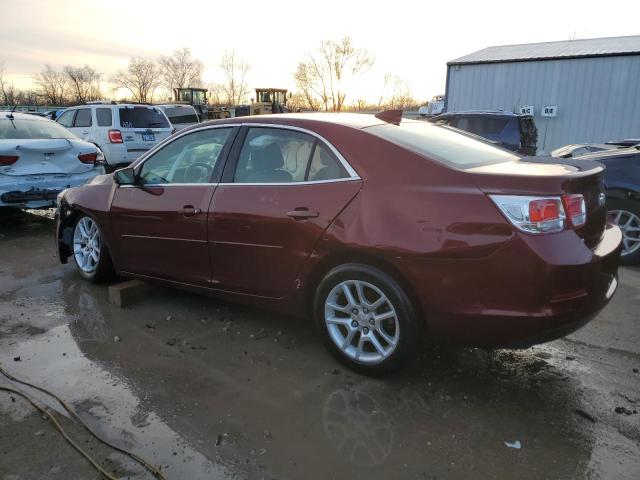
208,126 -> 361,298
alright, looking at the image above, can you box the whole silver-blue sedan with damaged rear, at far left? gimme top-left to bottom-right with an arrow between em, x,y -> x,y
0,112 -> 104,208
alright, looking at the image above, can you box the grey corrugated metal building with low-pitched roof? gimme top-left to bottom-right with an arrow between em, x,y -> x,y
445,35 -> 640,153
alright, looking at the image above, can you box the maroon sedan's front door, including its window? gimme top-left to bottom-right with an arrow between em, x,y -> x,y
111,127 -> 237,286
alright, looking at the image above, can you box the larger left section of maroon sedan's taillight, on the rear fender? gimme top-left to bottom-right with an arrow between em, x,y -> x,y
489,195 -> 566,233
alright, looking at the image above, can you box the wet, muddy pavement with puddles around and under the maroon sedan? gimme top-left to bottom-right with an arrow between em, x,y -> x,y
0,213 -> 640,480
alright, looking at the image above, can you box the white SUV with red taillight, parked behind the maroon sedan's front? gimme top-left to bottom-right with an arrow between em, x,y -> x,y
56,102 -> 173,172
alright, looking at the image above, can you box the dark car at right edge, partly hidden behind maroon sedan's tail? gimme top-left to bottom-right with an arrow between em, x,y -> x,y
576,146 -> 640,265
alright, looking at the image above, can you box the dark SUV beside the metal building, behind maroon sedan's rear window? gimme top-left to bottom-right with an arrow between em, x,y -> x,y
429,111 -> 538,156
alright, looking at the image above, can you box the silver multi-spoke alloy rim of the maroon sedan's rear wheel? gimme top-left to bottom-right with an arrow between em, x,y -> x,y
324,280 -> 400,364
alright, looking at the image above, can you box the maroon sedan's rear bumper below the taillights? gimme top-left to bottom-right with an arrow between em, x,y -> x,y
402,225 -> 622,348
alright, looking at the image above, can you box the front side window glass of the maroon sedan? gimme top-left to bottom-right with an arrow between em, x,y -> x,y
140,128 -> 231,184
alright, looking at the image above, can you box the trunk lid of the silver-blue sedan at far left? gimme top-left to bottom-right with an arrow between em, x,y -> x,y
0,138 -> 96,176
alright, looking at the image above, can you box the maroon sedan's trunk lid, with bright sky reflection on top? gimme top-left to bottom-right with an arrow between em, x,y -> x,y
465,157 -> 607,247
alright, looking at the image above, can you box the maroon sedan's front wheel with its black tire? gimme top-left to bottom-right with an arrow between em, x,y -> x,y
72,215 -> 115,283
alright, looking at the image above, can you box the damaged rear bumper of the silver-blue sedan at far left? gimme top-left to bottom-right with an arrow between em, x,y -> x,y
0,171 -> 104,208
